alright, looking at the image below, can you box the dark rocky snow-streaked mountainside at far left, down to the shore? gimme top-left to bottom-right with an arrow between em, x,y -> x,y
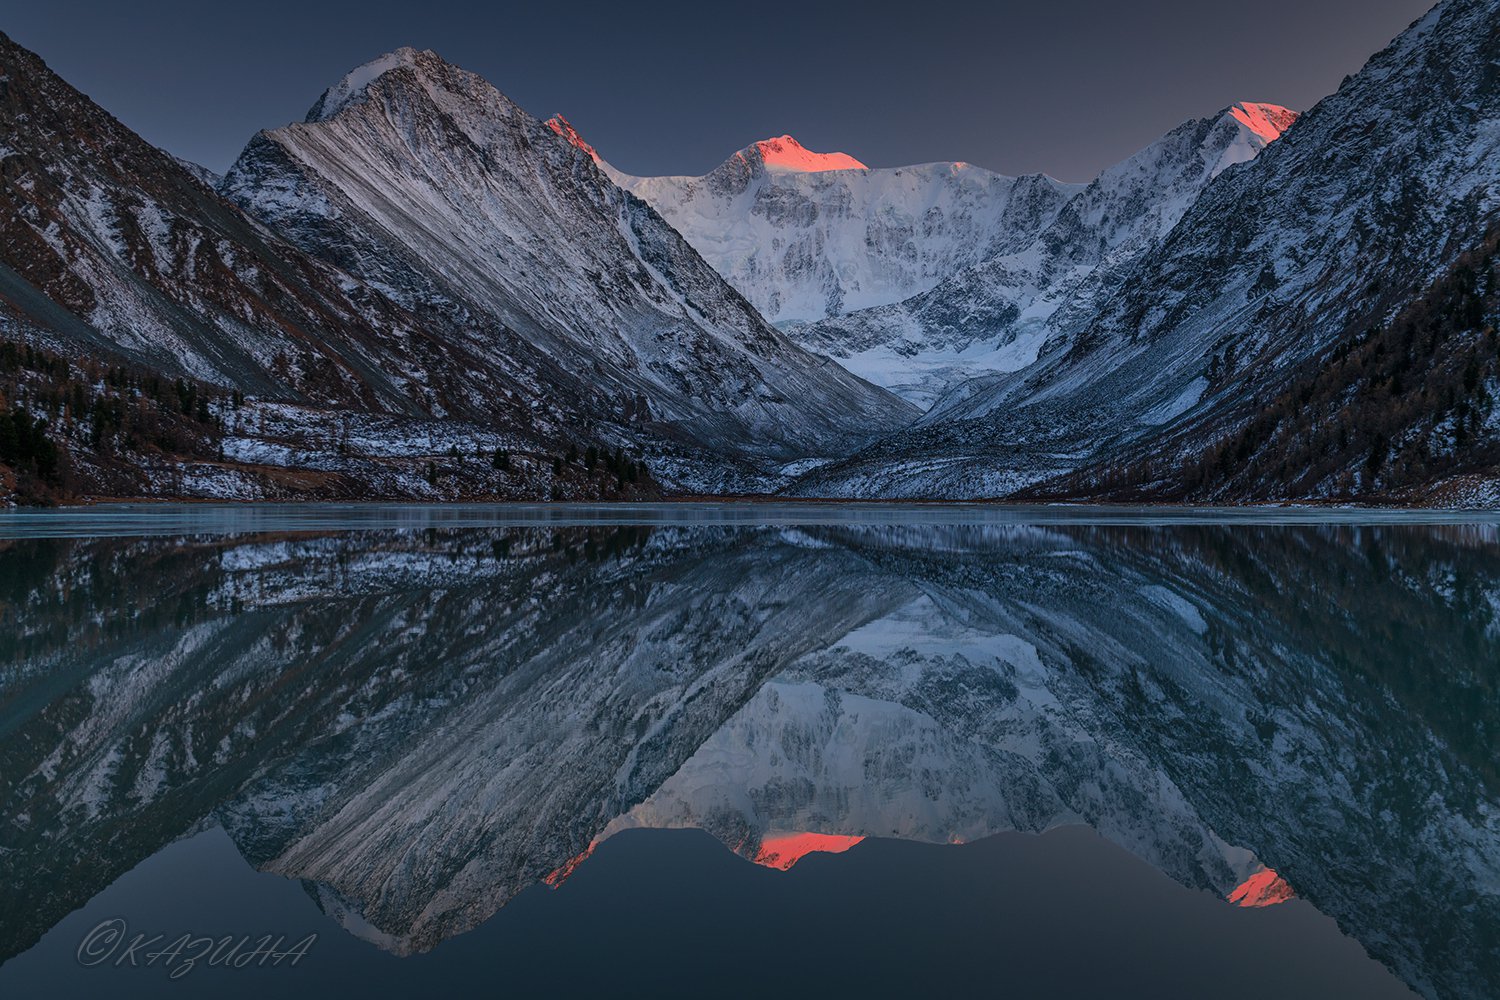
0,36 -> 675,499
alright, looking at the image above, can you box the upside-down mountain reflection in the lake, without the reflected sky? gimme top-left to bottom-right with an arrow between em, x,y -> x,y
0,523 -> 1500,997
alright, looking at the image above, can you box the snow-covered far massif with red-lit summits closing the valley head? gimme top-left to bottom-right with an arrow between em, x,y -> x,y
597,102 -> 1298,335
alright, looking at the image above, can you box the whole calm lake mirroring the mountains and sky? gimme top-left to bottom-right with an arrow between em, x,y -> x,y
0,504 -> 1500,1000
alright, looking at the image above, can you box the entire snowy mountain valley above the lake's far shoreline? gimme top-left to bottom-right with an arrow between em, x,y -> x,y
0,0 -> 1500,507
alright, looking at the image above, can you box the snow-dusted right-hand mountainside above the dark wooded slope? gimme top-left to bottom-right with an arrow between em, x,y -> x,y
797,0 -> 1500,501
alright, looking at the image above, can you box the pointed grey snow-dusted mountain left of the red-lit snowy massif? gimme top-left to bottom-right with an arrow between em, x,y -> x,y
222,48 -> 912,479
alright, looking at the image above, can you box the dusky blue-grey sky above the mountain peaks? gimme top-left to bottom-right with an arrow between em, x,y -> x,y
0,0 -> 1431,180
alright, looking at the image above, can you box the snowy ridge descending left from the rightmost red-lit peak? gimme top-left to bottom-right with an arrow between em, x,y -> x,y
794,103 -> 1298,405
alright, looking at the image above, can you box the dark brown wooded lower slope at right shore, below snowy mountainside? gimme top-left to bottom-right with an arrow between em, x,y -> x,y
1019,226 -> 1500,502
